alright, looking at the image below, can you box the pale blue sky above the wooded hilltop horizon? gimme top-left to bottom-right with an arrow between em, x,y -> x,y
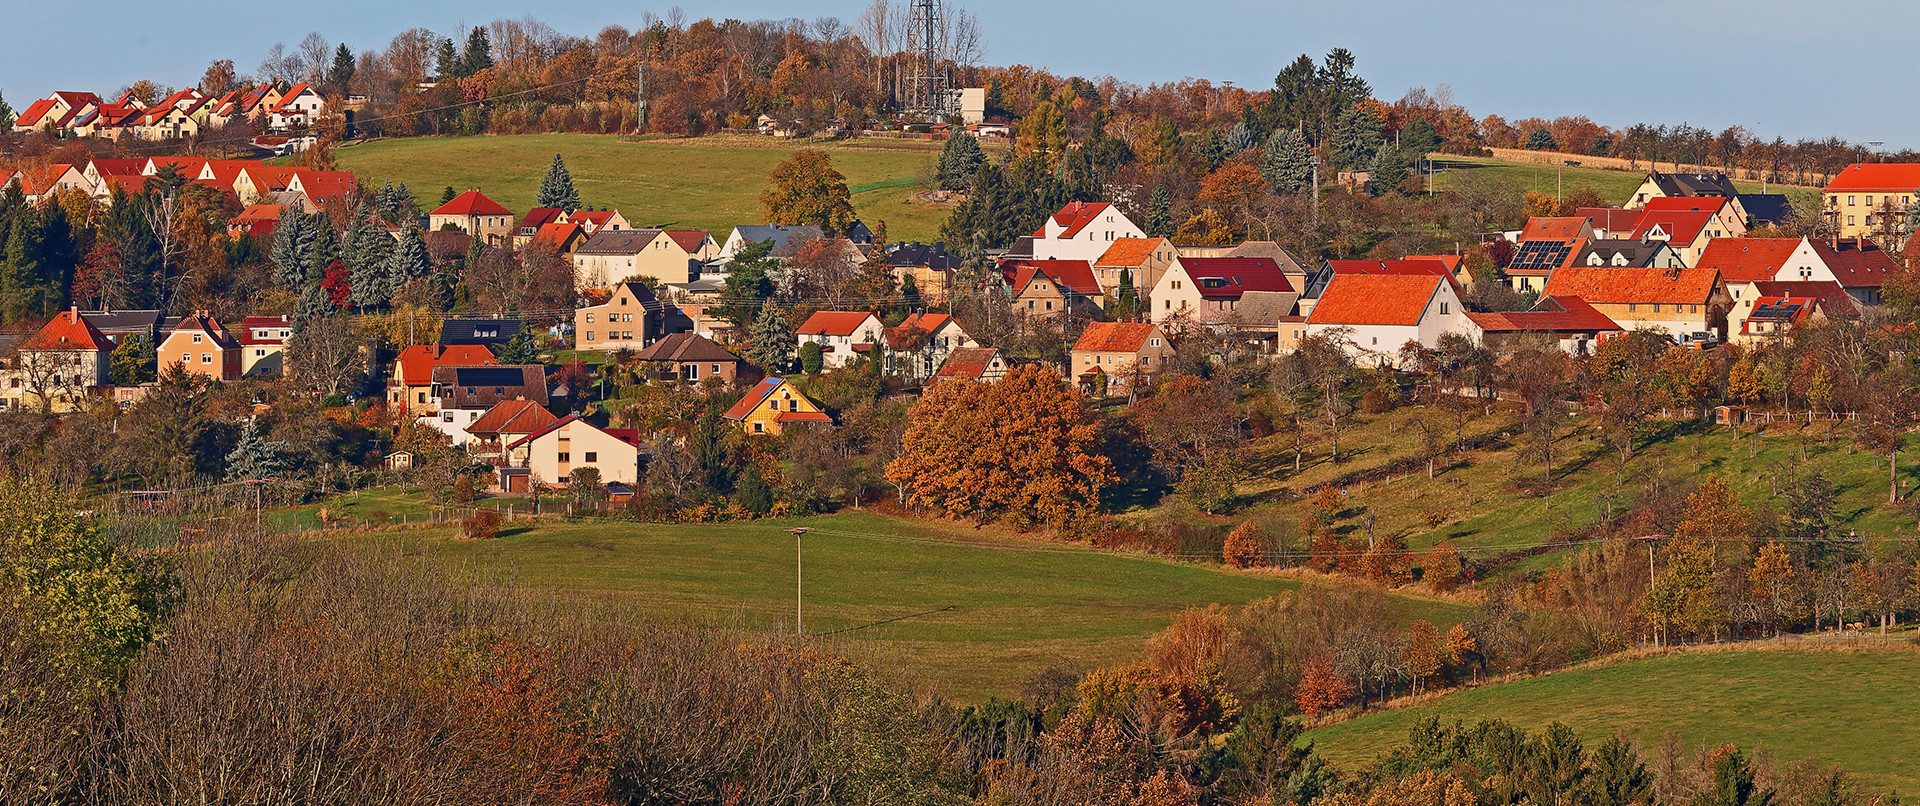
15,0 -> 1920,150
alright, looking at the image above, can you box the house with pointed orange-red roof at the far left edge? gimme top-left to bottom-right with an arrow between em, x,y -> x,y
0,309 -> 113,411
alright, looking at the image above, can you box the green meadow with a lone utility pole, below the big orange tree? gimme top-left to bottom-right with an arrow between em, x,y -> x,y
330,512 -> 1467,700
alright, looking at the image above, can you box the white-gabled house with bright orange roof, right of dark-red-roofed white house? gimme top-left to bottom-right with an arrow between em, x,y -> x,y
1306,273 -> 1478,367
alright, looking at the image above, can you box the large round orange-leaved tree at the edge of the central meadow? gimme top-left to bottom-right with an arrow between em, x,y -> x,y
887,365 -> 1114,528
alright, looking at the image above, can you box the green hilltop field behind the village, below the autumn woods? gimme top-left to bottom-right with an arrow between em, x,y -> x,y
336,134 -> 947,242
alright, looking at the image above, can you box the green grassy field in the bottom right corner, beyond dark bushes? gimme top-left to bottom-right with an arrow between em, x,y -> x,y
1308,651 -> 1920,793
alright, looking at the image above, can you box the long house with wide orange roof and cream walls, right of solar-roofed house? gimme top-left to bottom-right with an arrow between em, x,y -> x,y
1546,267 -> 1732,342
